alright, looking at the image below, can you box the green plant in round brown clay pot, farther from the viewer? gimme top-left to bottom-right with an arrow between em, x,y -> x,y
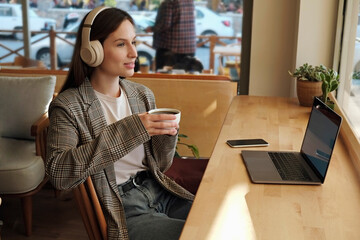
289,63 -> 322,107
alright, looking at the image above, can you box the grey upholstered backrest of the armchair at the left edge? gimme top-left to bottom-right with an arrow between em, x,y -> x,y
0,76 -> 56,140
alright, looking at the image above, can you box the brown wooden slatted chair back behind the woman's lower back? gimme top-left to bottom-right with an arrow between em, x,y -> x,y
73,177 -> 107,240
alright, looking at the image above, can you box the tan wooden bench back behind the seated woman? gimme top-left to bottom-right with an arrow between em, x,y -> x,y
0,69 -> 237,157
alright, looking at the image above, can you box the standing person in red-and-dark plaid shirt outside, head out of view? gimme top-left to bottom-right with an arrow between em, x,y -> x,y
147,0 -> 196,69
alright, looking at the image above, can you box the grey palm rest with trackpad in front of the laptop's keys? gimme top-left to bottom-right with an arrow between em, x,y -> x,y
241,151 -> 282,183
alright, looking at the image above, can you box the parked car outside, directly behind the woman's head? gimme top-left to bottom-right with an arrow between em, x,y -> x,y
30,16 -> 155,67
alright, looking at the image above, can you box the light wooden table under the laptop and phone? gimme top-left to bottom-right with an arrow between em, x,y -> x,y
180,96 -> 360,240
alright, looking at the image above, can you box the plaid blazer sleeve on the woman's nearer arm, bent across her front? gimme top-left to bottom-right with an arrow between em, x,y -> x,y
46,99 -> 150,189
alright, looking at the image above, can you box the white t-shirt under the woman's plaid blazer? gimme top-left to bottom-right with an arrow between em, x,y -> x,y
95,88 -> 147,185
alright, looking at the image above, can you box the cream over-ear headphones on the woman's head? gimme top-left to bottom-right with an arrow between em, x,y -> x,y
80,6 -> 108,67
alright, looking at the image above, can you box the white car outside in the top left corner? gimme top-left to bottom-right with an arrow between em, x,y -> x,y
0,3 -> 56,40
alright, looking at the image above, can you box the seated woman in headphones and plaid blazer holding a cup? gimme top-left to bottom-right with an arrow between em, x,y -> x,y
46,7 -> 193,240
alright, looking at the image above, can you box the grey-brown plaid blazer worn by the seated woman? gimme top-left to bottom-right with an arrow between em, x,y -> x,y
46,80 -> 193,239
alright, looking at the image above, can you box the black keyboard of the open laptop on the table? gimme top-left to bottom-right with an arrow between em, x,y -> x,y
269,152 -> 311,181
